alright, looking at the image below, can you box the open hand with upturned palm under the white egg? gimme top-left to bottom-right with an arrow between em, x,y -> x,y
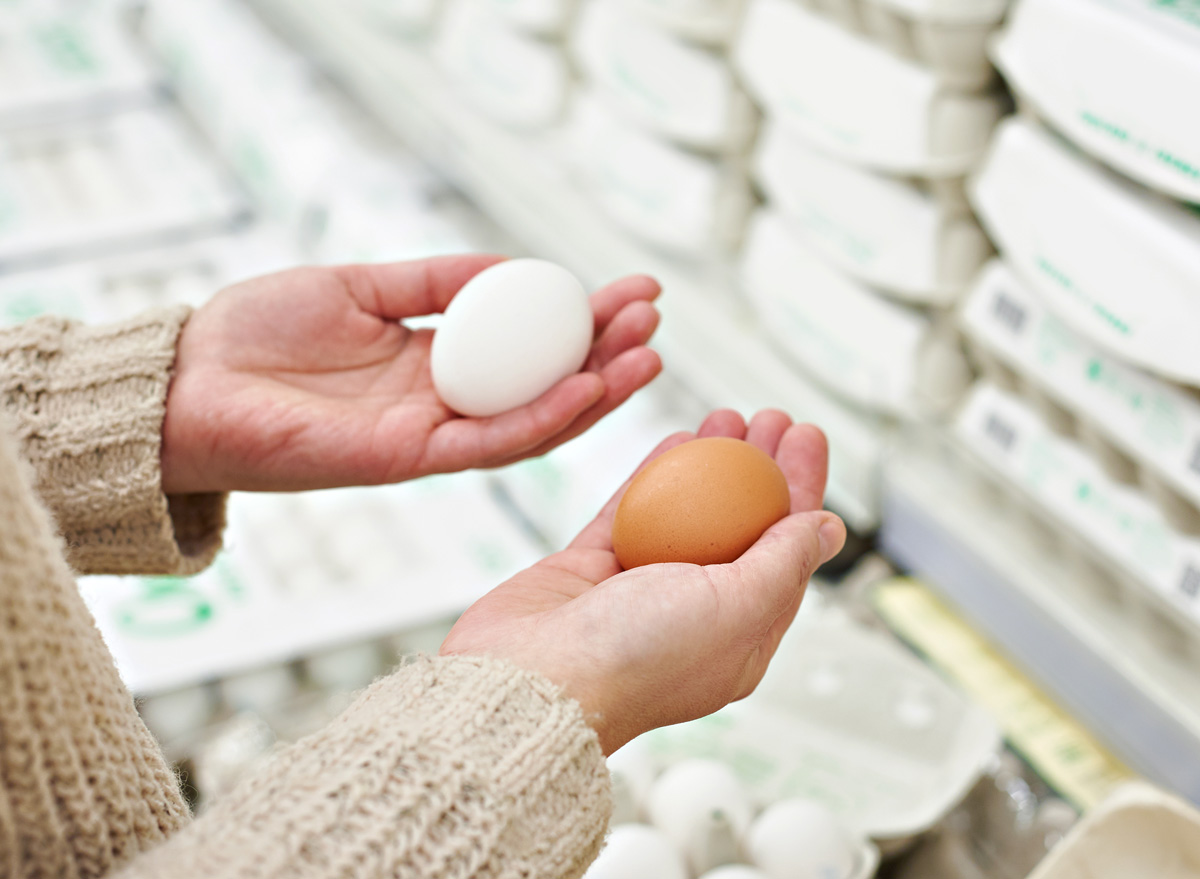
162,256 -> 661,494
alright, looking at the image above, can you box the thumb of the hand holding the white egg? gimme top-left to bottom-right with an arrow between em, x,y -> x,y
332,253 -> 508,321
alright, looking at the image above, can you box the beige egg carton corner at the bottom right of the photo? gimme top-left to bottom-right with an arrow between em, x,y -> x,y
1028,783 -> 1200,879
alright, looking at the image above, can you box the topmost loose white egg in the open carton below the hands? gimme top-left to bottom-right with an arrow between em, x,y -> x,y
646,760 -> 751,873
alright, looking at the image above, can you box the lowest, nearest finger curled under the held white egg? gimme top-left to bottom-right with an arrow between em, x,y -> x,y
426,372 -> 605,472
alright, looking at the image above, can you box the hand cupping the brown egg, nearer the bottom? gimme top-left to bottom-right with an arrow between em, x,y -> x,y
440,411 -> 846,754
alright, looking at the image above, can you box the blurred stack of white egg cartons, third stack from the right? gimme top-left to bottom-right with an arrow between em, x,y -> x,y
569,0 -> 757,257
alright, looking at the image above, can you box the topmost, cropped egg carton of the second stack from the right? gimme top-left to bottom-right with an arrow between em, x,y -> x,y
803,0 -> 1006,91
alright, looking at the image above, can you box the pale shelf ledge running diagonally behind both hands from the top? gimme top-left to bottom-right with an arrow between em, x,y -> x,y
243,0 -> 888,531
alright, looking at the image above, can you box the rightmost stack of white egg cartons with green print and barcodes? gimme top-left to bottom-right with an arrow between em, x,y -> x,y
959,0 -> 1200,662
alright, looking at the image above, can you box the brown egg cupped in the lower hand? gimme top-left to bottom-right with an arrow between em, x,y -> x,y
612,437 -> 791,570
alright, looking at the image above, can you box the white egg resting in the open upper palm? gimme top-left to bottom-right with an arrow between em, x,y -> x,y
430,259 -> 594,418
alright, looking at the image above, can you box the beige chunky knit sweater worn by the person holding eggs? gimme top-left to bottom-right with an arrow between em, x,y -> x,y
0,309 -> 611,879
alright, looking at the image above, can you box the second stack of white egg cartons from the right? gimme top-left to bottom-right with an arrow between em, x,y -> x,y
733,0 -> 1008,417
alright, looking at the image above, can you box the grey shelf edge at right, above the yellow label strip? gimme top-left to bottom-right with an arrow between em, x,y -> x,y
880,441 -> 1200,802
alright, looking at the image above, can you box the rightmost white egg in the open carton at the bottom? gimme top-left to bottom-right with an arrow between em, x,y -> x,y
746,797 -> 858,879
